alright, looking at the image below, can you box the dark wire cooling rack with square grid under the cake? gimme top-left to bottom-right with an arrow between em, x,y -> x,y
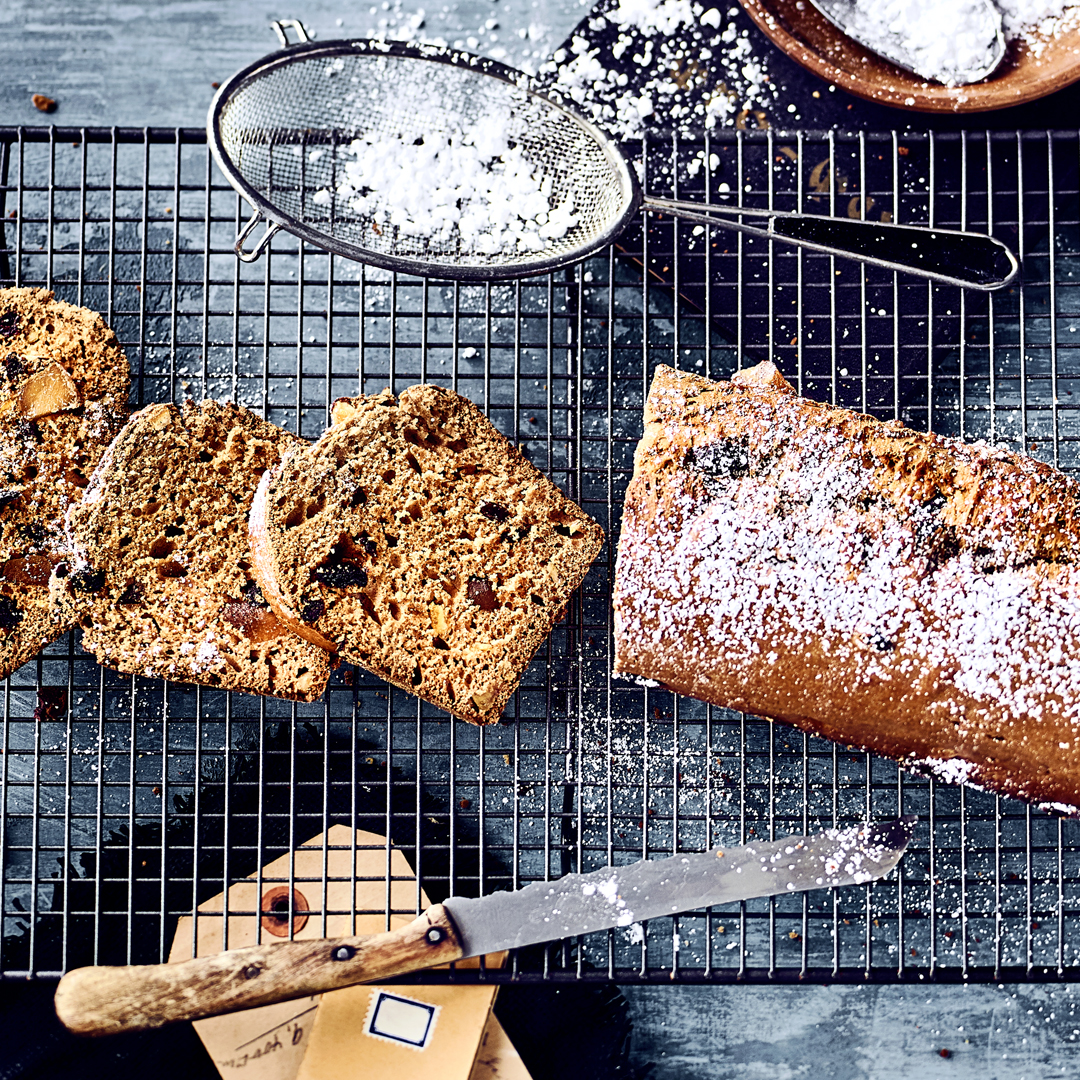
0,127 -> 1080,982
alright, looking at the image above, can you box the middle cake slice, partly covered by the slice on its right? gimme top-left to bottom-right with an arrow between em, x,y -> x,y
51,401 -> 328,701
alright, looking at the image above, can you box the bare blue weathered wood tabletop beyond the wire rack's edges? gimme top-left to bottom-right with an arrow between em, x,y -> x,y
0,0 -> 1080,1080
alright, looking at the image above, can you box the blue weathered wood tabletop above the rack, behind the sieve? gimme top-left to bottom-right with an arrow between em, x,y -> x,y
0,0 -> 585,127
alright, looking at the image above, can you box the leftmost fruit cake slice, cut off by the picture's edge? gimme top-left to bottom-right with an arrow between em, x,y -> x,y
0,288 -> 130,678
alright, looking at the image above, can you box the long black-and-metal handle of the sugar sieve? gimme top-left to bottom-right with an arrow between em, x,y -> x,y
644,199 -> 1020,292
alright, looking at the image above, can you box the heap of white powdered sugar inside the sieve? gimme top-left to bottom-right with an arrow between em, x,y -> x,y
313,122 -> 578,254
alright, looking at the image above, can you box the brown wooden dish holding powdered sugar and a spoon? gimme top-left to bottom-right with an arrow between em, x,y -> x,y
742,0 -> 1080,112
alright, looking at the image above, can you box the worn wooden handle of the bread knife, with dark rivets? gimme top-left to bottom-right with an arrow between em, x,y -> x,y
56,904 -> 462,1035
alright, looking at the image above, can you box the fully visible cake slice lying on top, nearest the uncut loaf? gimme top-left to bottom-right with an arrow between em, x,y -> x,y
251,386 -> 604,724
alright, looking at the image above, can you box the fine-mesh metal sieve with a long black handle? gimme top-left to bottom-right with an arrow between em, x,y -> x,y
206,21 -> 1017,289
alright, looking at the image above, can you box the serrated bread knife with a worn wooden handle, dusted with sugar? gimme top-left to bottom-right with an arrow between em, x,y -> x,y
56,818 -> 917,1035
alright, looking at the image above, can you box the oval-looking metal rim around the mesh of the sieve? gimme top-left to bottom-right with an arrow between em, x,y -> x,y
206,38 -> 643,281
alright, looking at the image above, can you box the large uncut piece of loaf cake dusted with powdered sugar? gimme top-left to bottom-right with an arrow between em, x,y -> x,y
615,364 -> 1080,813
